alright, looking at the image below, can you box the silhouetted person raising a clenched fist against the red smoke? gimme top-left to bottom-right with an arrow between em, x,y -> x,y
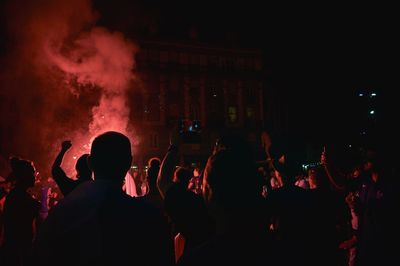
51,140 -> 92,196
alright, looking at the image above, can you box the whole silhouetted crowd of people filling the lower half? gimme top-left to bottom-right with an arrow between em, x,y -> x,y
0,132 -> 398,266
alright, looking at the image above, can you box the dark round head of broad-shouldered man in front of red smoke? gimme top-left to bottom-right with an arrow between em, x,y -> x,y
88,131 -> 132,182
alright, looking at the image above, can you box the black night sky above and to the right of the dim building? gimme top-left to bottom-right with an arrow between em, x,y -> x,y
95,0 -> 398,144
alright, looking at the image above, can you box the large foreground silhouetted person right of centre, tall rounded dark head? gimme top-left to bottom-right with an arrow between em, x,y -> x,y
179,137 -> 274,265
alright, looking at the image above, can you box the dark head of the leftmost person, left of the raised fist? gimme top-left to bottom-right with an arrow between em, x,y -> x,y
10,157 -> 37,190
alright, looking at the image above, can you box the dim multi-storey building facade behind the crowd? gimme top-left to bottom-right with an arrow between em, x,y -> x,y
130,41 -> 276,170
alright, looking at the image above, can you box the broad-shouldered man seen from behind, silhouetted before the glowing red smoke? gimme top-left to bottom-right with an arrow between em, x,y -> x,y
35,132 -> 173,266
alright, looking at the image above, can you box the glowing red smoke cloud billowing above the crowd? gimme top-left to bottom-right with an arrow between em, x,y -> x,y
0,0 -> 136,179
